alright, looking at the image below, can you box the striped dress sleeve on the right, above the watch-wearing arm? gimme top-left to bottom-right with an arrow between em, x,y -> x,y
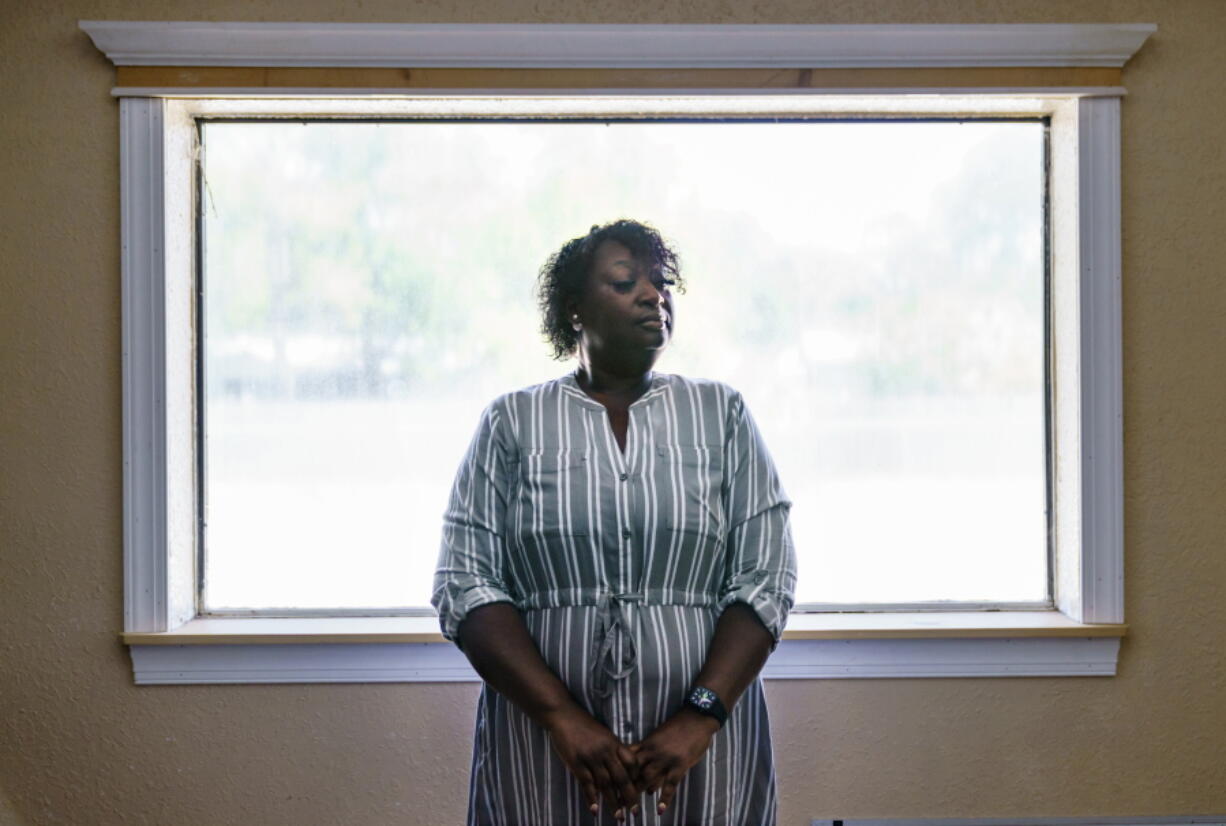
718,391 -> 796,651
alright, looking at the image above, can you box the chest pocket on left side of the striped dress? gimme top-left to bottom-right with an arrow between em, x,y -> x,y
515,447 -> 592,539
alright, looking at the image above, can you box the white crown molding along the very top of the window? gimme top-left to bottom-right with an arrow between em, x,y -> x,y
80,20 -> 1157,69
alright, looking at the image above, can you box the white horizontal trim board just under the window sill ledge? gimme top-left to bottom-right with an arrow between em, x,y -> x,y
130,637 -> 1119,685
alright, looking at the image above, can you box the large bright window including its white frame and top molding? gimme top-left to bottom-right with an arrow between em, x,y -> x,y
90,21 -> 1155,683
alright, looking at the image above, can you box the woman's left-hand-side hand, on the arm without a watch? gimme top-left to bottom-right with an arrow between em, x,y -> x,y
544,706 -> 640,820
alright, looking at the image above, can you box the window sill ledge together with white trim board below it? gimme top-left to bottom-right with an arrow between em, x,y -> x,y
121,612 -> 1127,685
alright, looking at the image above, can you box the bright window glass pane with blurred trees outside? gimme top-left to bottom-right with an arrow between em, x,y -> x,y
202,121 -> 1047,610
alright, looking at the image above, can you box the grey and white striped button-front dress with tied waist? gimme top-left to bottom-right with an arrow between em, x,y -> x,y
432,373 -> 796,826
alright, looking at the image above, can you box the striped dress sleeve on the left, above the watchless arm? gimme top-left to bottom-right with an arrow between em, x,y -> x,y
430,401 -> 515,648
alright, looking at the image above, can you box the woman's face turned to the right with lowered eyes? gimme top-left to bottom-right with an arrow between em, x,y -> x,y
571,240 -> 673,353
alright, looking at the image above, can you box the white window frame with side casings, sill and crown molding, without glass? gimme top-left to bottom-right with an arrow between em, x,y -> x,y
81,21 -> 1156,684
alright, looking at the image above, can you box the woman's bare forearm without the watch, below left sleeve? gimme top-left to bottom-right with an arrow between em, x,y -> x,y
459,602 -> 586,727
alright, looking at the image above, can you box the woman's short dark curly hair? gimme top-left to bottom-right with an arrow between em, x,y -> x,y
536,218 -> 685,362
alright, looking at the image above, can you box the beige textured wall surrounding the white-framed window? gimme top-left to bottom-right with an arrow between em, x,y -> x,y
0,0 -> 1226,826
